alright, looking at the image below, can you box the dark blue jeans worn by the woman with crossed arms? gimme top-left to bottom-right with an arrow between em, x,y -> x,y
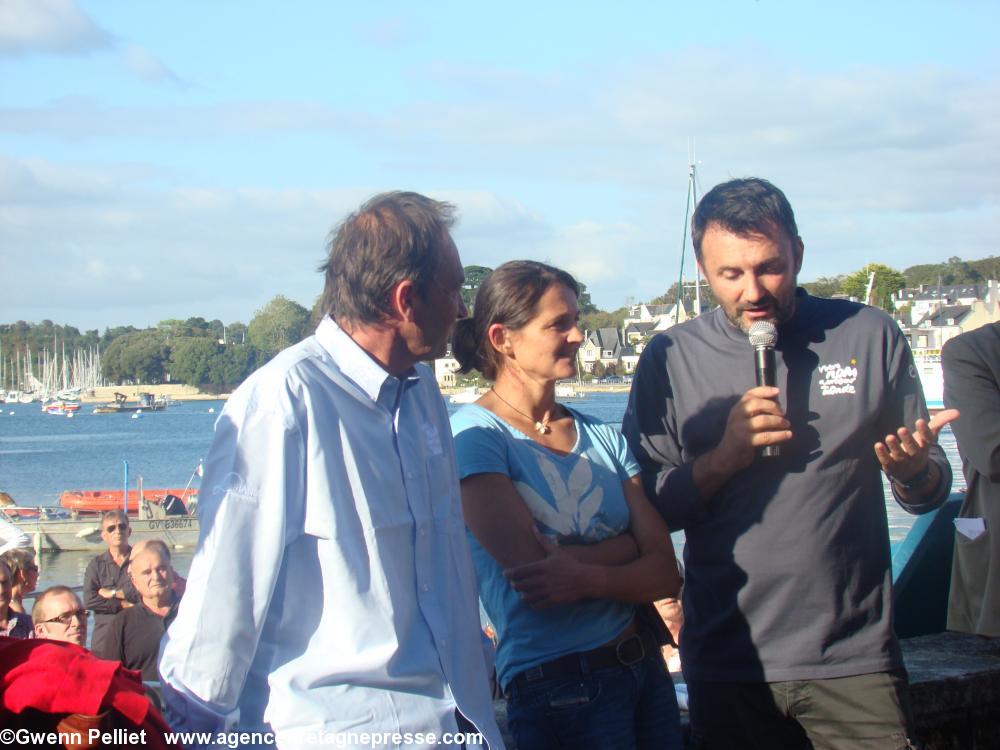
507,652 -> 684,750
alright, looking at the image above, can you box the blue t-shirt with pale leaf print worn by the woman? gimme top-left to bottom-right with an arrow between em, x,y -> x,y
451,404 -> 639,687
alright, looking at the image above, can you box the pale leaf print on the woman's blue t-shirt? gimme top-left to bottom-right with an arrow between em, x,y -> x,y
514,457 -> 622,542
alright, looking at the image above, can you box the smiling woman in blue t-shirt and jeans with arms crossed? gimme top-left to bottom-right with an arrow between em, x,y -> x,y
451,261 -> 681,750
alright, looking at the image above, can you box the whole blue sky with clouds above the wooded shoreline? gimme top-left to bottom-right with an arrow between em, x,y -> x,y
0,0 -> 1000,330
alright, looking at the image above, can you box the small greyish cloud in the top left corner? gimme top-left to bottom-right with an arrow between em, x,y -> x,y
0,0 -> 112,57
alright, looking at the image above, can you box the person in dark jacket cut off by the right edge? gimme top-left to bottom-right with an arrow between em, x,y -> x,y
941,323 -> 1000,637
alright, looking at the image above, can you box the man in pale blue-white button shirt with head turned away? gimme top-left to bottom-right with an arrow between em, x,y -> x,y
160,193 -> 503,748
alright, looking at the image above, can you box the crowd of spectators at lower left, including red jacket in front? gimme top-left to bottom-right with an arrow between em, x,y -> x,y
0,511 -> 183,747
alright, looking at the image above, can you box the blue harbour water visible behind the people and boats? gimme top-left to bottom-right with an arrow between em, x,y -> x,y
0,392 -> 964,590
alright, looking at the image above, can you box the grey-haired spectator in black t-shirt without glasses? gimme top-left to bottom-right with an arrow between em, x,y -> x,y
109,540 -> 178,680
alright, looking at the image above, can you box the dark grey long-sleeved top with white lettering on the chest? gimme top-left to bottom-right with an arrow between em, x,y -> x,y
623,290 -> 951,682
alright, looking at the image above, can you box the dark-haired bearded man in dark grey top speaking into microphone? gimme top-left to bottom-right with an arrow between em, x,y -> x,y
623,179 -> 957,750
